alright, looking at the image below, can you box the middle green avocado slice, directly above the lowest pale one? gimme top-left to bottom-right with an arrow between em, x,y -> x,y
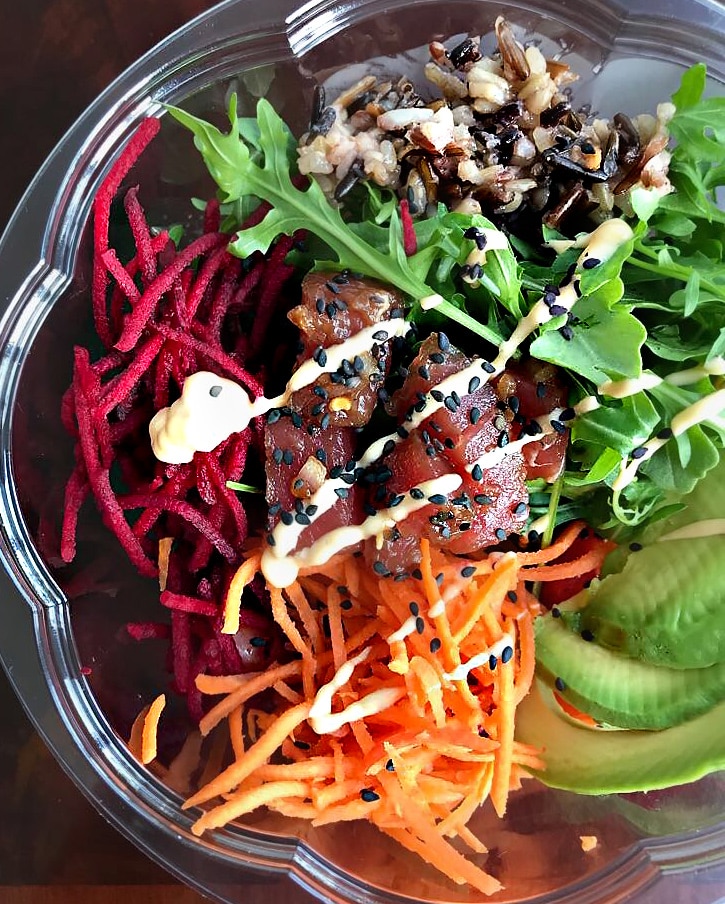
536,615 -> 725,730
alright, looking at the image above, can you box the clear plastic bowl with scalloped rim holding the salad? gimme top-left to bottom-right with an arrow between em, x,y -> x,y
0,0 -> 725,904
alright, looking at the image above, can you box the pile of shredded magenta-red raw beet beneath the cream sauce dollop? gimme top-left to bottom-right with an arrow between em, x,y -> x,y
61,119 -> 301,720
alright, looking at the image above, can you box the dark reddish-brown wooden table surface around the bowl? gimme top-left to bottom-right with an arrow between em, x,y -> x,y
0,0 -> 311,904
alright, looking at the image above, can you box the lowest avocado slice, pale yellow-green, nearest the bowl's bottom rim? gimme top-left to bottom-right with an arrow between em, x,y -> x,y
516,683 -> 725,794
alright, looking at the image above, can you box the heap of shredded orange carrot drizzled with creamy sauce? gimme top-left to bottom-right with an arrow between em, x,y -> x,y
129,524 -> 600,894
